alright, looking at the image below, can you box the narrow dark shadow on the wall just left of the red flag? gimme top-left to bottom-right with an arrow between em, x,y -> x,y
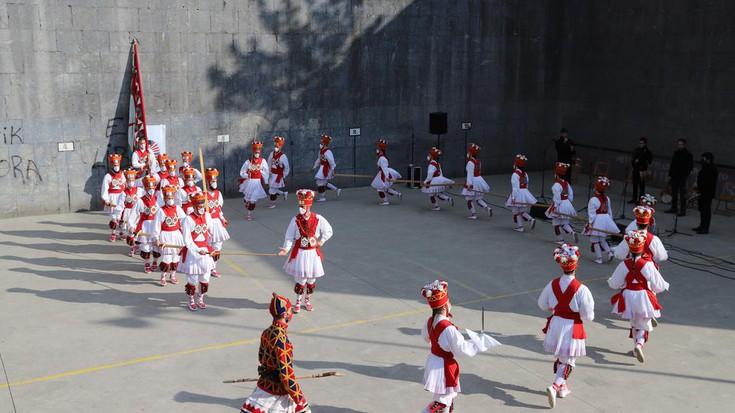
82,45 -> 133,212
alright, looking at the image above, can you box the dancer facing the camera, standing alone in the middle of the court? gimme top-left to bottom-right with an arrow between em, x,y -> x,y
278,189 -> 332,313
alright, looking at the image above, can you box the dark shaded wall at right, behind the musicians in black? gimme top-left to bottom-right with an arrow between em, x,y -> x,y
559,0 -> 735,166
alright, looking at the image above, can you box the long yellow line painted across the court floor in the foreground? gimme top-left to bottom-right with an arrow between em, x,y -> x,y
0,276 -> 606,389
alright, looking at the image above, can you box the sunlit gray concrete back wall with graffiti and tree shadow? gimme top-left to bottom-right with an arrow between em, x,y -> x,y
0,0 -> 561,217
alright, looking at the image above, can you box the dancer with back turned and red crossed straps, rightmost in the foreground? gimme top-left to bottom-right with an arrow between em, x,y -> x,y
607,231 -> 669,363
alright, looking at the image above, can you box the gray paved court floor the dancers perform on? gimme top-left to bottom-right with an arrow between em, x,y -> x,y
0,175 -> 735,413
